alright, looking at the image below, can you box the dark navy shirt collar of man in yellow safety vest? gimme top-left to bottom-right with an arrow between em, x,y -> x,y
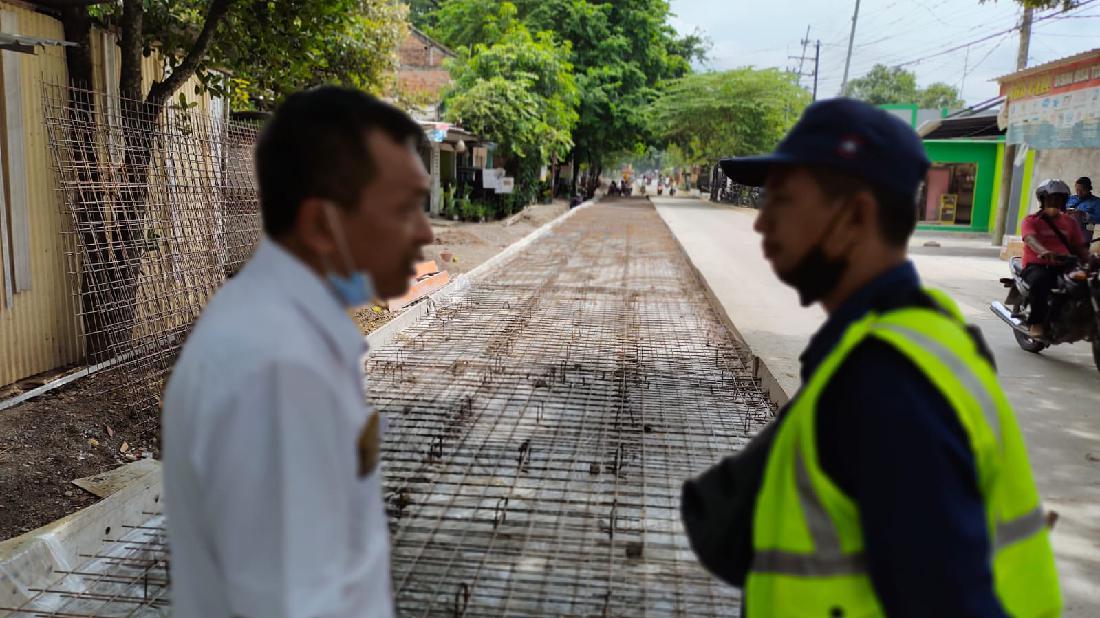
799,262 -> 921,383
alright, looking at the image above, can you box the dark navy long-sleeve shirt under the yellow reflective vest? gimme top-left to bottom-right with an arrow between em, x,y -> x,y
801,263 -> 1005,617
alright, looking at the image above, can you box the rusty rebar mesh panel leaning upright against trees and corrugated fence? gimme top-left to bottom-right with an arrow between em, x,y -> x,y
43,84 -> 260,408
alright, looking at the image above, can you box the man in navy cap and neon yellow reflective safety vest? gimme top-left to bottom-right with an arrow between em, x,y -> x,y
684,99 -> 1062,618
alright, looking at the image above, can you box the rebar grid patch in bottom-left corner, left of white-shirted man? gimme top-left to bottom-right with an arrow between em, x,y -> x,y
0,514 -> 169,618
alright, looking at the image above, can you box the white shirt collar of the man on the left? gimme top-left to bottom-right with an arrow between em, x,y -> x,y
249,236 -> 366,364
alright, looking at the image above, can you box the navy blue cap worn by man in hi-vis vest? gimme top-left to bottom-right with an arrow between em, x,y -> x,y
719,98 -> 931,197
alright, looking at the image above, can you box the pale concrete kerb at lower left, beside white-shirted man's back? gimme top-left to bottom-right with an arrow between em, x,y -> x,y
0,459 -> 162,607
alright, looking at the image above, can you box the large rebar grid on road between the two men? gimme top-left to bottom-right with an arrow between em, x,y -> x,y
367,200 -> 772,616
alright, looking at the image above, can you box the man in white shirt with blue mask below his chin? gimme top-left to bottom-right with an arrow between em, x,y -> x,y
163,87 -> 432,618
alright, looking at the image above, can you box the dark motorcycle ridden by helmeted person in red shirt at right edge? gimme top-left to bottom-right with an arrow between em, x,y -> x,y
989,239 -> 1100,371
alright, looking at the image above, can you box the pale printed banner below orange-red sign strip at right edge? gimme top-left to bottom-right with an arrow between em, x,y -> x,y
1005,87 -> 1100,150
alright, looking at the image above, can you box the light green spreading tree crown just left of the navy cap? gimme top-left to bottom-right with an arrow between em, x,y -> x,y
649,68 -> 810,164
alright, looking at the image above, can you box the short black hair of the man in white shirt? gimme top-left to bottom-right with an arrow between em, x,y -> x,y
256,86 -> 424,236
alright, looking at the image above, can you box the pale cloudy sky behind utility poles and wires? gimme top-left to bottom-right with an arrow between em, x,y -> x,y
671,0 -> 1100,104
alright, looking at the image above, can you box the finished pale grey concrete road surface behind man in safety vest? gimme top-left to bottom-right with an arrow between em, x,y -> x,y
651,197 -> 1100,618
